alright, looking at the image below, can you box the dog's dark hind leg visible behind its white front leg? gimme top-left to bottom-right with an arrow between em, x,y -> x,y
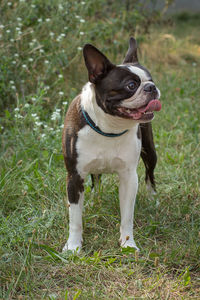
139,123 -> 157,194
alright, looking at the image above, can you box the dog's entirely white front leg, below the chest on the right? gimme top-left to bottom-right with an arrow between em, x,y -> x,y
119,170 -> 139,250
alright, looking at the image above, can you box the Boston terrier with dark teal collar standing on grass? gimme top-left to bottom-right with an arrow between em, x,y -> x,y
62,37 -> 161,252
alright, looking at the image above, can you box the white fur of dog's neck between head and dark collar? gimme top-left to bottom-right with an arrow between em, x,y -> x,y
81,82 -> 138,133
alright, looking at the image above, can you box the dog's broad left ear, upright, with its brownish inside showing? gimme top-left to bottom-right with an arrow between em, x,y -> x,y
83,44 -> 114,83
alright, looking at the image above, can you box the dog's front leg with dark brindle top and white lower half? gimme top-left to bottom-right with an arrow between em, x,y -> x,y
63,174 -> 84,252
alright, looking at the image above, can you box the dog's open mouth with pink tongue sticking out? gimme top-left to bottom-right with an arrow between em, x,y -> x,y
117,99 -> 162,121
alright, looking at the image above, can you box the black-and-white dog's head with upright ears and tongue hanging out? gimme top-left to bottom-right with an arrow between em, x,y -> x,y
83,38 -> 161,123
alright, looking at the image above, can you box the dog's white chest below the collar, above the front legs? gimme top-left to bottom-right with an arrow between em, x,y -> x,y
77,126 -> 141,177
